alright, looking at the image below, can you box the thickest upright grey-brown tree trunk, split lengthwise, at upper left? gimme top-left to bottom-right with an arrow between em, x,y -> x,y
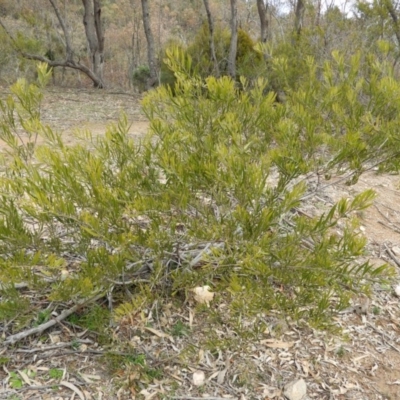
82,0 -> 104,88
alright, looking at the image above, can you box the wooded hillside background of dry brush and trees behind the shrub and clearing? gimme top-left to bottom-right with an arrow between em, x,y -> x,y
0,0 -> 392,90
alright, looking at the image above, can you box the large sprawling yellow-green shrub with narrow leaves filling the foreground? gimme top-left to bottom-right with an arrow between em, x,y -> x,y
0,49 -> 400,336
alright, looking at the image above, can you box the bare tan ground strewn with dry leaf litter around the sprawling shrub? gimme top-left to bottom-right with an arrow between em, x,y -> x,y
0,88 -> 400,400
